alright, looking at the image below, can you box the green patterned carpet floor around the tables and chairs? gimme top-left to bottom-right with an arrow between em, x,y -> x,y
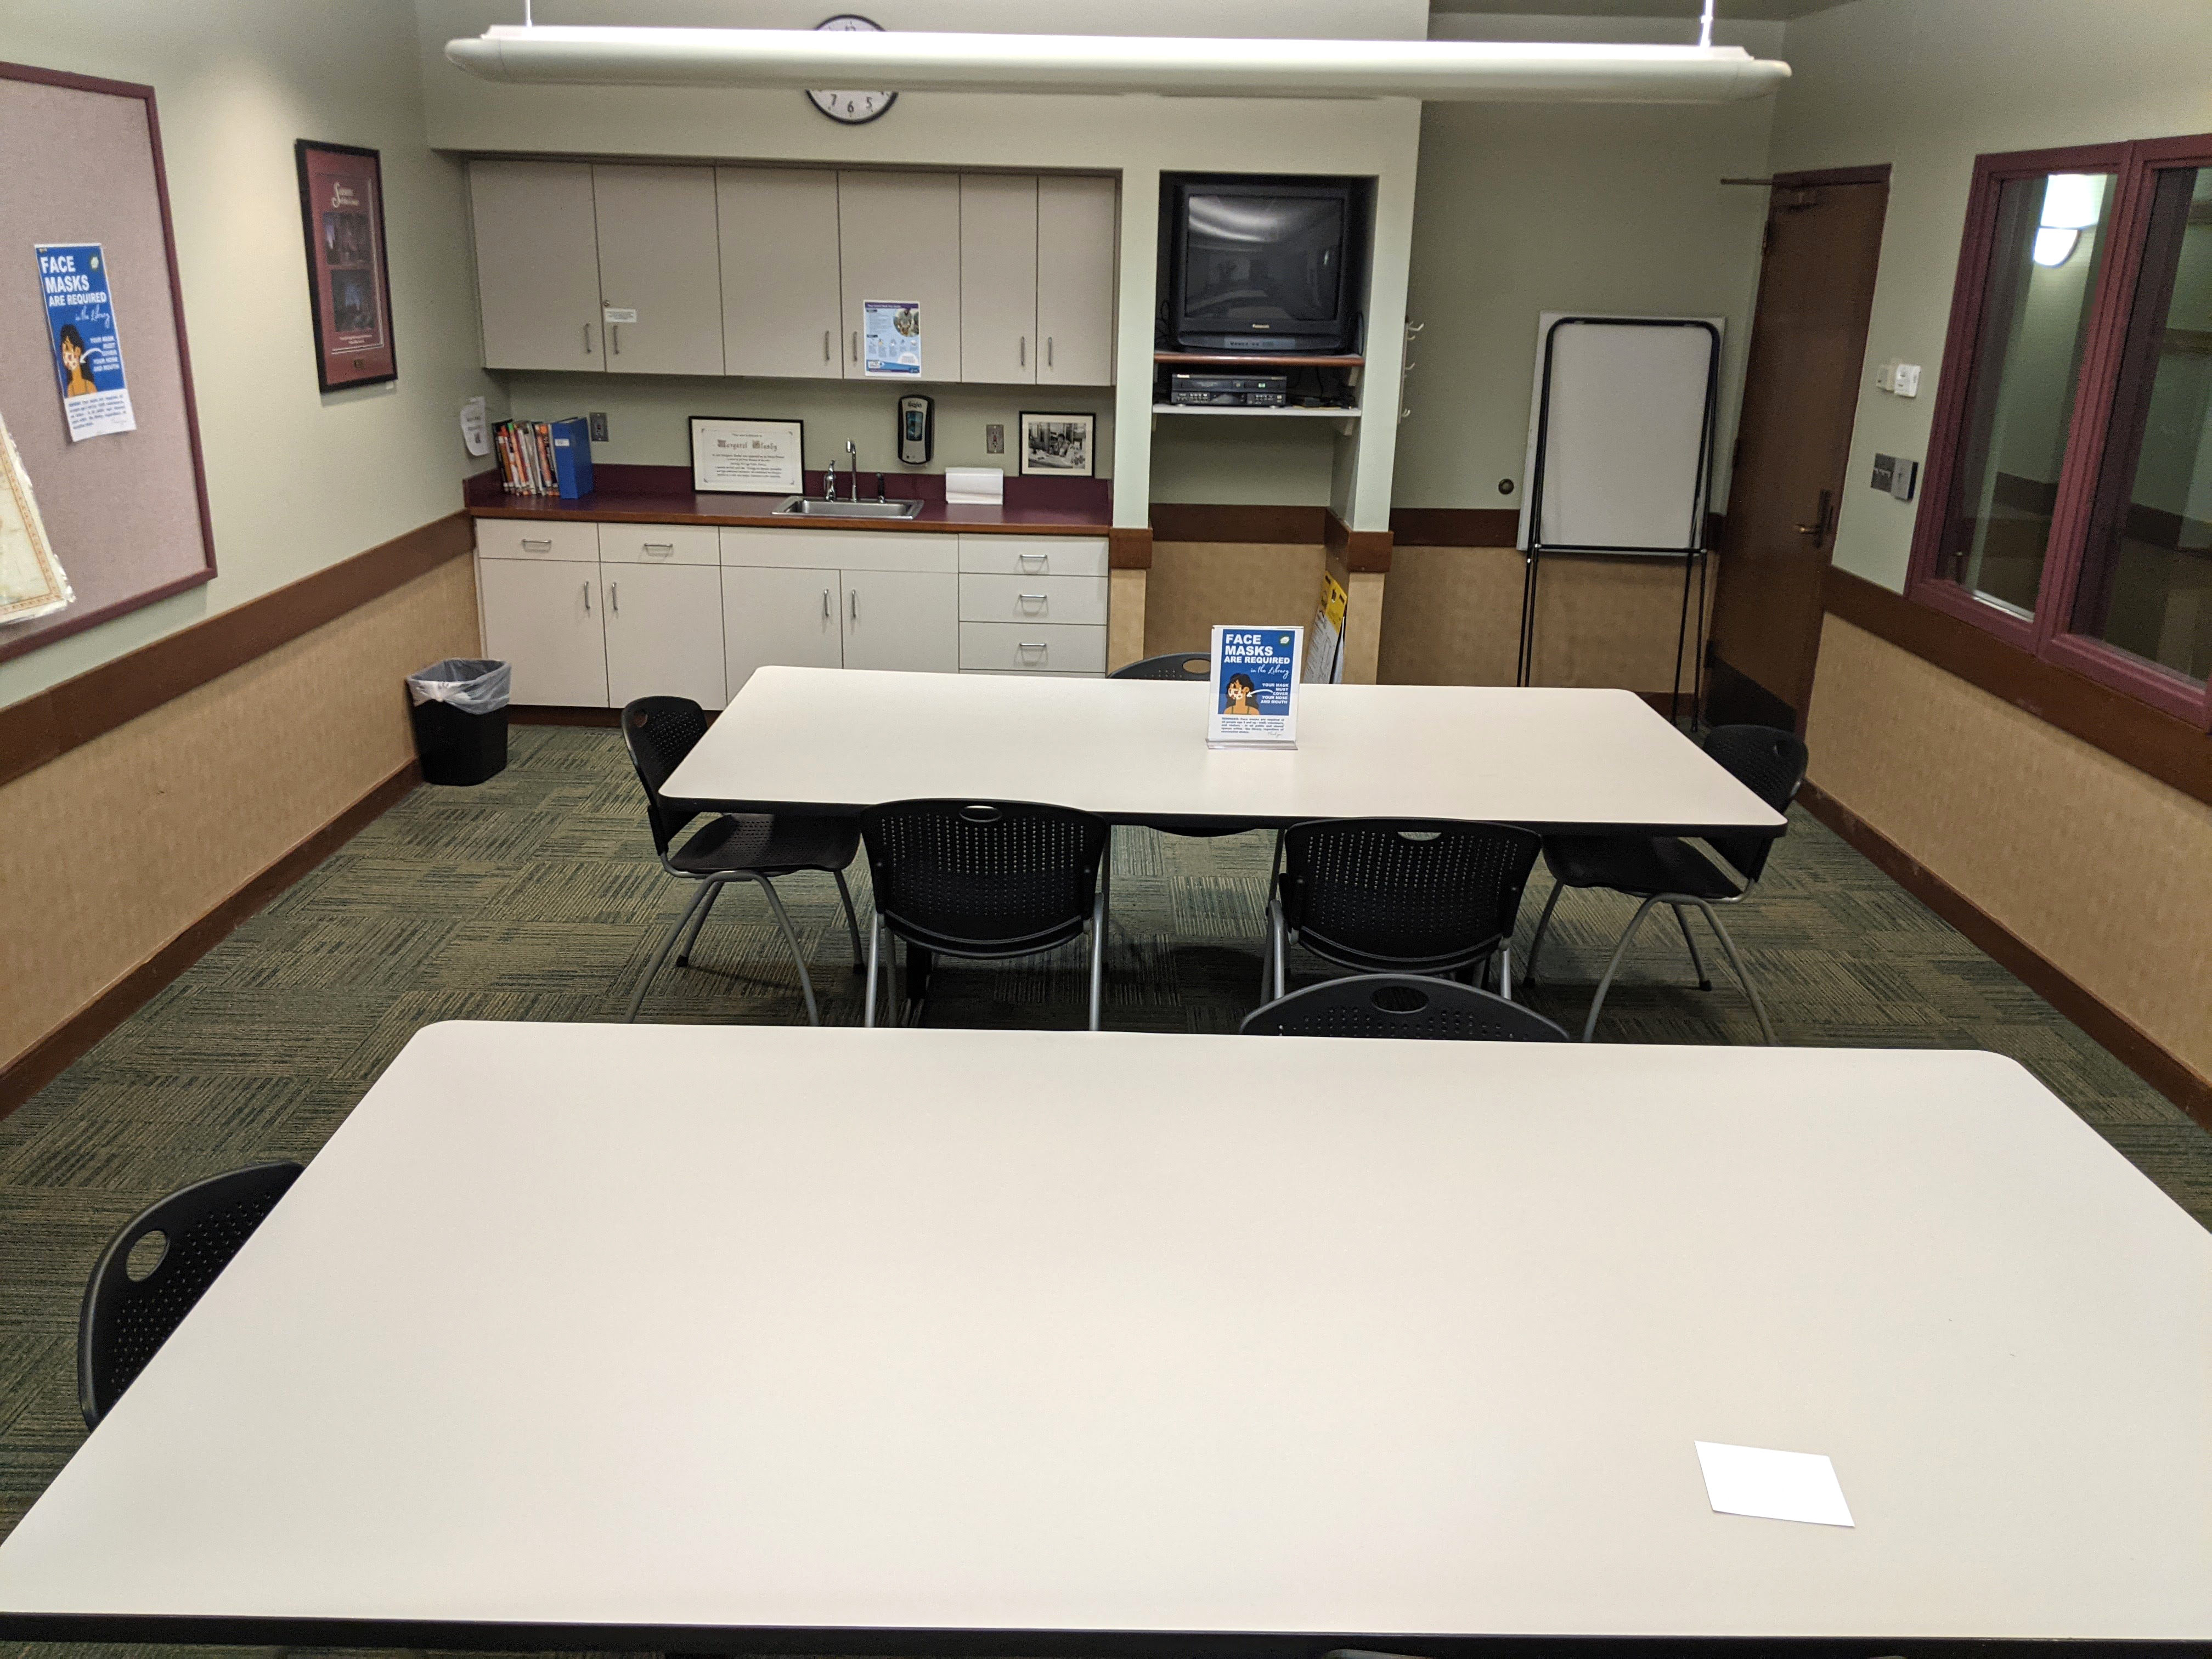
0,725 -> 2212,1655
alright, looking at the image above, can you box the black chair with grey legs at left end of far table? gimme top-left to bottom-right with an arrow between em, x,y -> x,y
622,697 -> 860,1026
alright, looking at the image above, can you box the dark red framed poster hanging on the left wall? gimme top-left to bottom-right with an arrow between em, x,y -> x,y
292,139 -> 400,392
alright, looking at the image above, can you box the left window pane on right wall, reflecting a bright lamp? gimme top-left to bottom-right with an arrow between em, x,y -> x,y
1936,172 -> 2113,617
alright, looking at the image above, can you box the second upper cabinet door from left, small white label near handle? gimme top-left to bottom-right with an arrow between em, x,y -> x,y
591,166 -> 721,374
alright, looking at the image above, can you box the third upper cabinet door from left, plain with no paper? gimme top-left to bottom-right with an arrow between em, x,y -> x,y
714,168 -> 845,381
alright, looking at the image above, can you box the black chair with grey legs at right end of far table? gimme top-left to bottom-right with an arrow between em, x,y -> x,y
1528,725 -> 1807,1044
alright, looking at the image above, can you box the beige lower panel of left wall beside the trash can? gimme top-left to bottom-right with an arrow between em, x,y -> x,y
0,560 -> 480,1066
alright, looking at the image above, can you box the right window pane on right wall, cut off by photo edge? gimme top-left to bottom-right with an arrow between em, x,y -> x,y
2073,168 -> 2212,681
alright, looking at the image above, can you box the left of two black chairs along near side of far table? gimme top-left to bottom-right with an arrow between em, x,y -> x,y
860,801 -> 1106,1031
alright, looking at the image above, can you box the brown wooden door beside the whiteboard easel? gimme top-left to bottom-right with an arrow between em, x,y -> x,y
1706,168 -> 1889,730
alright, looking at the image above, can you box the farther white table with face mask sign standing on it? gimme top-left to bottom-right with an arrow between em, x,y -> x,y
666,668 -> 1785,836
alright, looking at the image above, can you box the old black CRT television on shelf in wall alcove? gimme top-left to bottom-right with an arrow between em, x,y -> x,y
1164,179 -> 1361,352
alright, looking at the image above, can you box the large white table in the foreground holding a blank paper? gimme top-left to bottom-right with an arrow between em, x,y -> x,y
0,1024 -> 2212,1659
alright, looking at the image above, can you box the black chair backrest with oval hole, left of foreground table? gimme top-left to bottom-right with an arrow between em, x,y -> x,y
77,1164 -> 298,1427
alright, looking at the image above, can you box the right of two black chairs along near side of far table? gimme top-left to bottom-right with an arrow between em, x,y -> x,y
1261,819 -> 1544,1000
